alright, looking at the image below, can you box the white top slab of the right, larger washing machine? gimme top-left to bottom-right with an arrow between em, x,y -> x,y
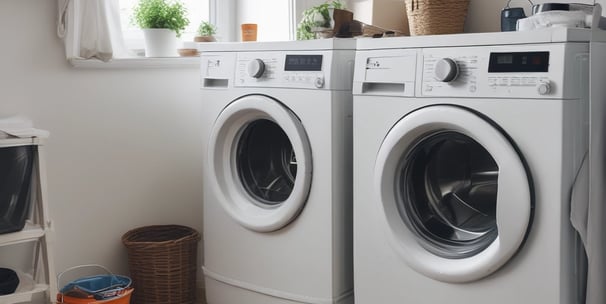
357,27 -> 606,50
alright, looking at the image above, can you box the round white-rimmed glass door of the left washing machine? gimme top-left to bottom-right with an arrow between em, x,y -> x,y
208,95 -> 312,232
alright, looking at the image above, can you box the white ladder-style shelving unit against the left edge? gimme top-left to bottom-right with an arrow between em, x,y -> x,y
0,138 -> 57,304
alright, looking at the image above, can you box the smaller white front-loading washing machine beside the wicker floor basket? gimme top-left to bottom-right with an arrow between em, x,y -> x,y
200,39 -> 355,304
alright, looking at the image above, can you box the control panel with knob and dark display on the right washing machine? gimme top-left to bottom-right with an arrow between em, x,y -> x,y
418,44 -> 584,98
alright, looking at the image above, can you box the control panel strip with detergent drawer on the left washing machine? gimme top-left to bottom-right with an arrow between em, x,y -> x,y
200,49 -> 355,91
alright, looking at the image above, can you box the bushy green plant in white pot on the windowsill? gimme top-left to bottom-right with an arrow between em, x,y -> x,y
133,0 -> 189,57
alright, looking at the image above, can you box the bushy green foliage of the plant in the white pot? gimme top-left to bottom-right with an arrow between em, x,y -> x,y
133,0 -> 189,37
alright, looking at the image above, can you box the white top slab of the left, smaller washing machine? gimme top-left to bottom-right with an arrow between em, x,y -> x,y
198,38 -> 356,52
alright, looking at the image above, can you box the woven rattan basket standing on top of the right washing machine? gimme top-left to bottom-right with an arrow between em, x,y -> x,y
406,0 -> 469,36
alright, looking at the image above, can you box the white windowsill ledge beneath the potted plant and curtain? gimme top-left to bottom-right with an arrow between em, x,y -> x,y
69,57 -> 200,69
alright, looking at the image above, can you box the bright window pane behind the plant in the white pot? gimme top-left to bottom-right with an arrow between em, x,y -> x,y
120,0 -> 210,50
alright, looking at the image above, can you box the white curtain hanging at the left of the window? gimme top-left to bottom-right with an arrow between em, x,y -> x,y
57,0 -> 133,61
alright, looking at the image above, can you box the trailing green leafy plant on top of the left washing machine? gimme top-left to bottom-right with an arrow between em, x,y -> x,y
297,0 -> 345,40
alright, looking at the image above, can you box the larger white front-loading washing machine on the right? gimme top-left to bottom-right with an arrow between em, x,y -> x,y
353,28 -> 591,304
